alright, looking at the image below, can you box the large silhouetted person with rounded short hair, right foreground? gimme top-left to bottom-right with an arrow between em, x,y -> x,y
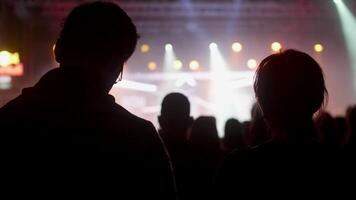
216,50 -> 347,199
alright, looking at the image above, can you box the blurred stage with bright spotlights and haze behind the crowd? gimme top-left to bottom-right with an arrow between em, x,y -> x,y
0,0 -> 356,136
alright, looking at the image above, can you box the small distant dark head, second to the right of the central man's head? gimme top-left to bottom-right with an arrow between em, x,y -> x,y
223,118 -> 246,152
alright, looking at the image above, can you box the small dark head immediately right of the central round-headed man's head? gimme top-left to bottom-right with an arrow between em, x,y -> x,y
188,116 -> 220,151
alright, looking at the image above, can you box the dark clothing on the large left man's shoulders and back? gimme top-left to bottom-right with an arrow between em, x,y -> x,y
0,68 -> 175,199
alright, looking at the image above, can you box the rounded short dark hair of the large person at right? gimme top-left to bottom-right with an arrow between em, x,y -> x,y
254,50 -> 327,116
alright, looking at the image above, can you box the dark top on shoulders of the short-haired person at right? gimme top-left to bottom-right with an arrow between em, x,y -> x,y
215,142 -> 351,199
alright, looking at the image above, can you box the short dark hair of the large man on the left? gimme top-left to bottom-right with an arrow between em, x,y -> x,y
56,2 -> 138,61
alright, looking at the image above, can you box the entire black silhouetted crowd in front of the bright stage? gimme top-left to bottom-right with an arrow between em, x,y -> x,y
0,2 -> 356,200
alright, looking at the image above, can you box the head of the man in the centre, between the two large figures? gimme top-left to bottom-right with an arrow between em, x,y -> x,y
158,93 -> 193,137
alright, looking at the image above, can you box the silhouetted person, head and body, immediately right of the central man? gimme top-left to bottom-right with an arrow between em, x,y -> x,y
189,116 -> 222,199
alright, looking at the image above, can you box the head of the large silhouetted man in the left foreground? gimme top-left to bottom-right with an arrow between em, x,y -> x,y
55,2 -> 138,91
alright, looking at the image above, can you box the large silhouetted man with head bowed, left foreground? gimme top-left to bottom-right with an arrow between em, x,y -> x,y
0,2 -> 175,199
